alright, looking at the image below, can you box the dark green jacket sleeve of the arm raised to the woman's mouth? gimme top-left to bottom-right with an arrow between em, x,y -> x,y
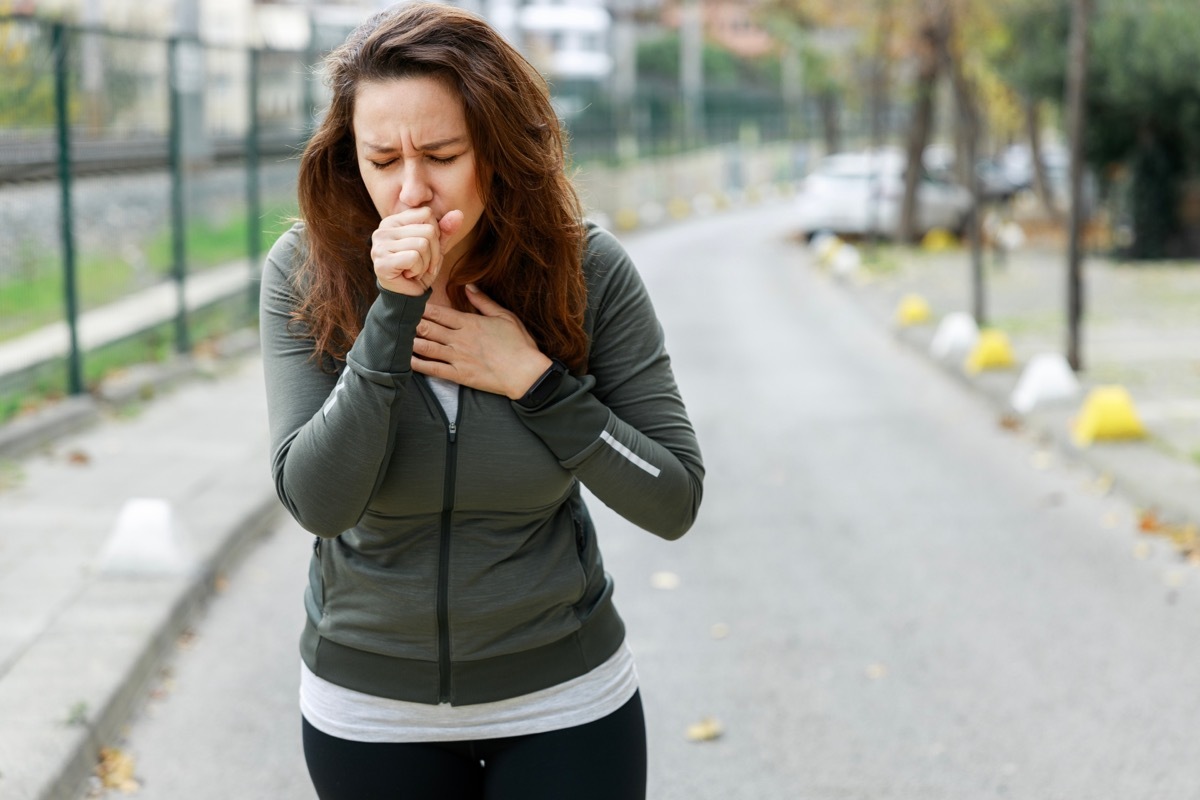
259,224 -> 428,537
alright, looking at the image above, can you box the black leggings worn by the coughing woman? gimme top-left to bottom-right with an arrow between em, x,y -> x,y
304,693 -> 646,800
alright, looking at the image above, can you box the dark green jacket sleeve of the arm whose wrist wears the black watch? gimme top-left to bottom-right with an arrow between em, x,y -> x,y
514,221 -> 704,540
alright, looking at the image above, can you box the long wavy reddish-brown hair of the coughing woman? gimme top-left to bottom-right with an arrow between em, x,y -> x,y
294,4 -> 588,371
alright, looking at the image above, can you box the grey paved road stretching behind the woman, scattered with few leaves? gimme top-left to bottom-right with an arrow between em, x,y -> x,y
96,207 -> 1200,800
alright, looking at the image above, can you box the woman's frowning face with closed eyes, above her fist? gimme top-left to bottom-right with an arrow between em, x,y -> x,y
353,77 -> 484,262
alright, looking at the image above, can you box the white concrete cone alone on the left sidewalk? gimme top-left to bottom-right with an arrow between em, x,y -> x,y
97,498 -> 194,577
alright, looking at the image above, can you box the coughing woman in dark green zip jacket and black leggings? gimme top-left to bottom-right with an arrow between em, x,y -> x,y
262,5 -> 703,800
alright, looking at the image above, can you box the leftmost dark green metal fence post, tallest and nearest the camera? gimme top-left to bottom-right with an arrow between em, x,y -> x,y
50,23 -> 83,395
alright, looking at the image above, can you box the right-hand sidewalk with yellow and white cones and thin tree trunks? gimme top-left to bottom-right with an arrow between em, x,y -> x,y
830,245 -> 1200,532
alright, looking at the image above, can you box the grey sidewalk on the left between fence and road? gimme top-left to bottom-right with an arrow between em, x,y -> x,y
0,353 -> 278,800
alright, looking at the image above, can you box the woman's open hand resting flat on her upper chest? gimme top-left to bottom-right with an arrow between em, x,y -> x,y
413,285 -> 551,399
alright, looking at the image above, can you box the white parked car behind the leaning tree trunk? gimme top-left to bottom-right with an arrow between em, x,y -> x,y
797,150 -> 971,239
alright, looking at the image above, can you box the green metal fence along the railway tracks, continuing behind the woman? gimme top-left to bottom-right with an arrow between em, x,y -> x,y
0,17 -> 803,421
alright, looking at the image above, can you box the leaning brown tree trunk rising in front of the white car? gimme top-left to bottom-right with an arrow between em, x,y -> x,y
898,0 -> 948,242
